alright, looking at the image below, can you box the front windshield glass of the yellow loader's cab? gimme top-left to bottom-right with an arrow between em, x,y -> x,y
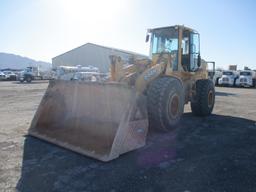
151,28 -> 178,54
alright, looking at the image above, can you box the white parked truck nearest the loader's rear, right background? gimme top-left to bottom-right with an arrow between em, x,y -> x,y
218,70 -> 239,86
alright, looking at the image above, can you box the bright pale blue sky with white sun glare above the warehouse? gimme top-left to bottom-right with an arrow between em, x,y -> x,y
0,0 -> 256,69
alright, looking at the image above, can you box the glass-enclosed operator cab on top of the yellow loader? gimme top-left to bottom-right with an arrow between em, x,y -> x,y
146,25 -> 201,72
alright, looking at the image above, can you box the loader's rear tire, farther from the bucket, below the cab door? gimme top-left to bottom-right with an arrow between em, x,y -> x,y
190,79 -> 215,116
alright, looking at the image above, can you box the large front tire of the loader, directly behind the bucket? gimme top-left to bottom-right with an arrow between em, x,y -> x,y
147,77 -> 185,131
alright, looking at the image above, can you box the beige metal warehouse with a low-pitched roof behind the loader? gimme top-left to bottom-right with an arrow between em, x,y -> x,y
52,43 -> 148,72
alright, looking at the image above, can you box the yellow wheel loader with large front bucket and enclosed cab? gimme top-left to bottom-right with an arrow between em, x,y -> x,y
29,25 -> 215,161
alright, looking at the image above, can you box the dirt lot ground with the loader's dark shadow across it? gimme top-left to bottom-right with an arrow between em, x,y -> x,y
0,81 -> 256,192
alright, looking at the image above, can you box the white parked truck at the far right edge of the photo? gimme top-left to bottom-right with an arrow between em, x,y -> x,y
236,70 -> 256,87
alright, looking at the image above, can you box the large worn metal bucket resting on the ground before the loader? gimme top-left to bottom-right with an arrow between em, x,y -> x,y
29,80 -> 148,161
